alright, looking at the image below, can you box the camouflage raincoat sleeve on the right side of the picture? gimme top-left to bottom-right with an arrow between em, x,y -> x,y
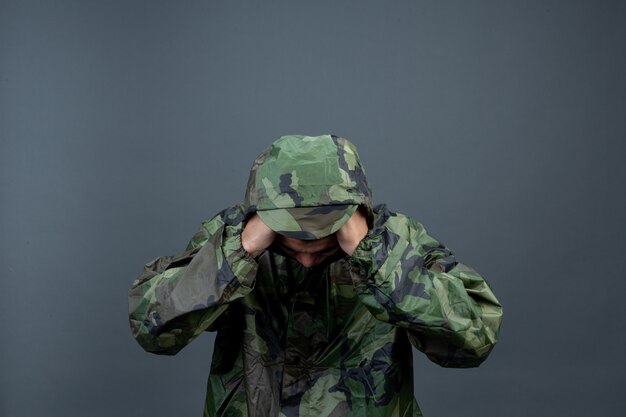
350,206 -> 502,367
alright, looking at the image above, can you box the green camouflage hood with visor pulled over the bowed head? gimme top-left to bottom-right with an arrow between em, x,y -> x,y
245,135 -> 372,239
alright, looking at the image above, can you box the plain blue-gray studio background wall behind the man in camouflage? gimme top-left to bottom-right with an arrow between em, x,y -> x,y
0,0 -> 626,417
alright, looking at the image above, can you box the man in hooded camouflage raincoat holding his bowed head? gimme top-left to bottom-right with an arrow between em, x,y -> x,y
130,135 -> 501,417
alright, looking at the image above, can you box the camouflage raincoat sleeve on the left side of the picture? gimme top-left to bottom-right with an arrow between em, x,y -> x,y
129,206 -> 257,355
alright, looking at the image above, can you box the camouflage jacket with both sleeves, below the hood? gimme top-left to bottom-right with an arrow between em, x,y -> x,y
129,206 -> 502,417
